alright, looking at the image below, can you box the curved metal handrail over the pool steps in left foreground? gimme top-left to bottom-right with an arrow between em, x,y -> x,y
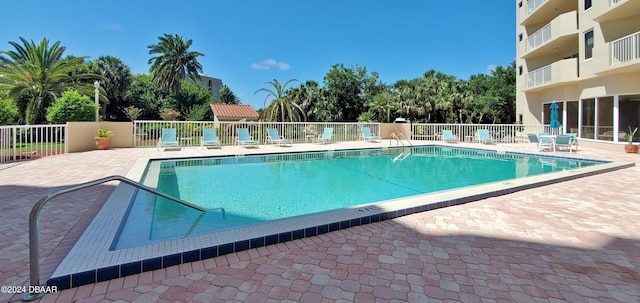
22,175 -> 220,302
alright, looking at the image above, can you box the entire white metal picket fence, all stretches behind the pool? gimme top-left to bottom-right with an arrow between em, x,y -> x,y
0,120 -> 576,164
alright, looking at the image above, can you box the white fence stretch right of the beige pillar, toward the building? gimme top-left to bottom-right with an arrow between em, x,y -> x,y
411,123 -> 546,143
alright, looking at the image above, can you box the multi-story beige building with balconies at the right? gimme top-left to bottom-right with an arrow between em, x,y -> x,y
516,0 -> 640,143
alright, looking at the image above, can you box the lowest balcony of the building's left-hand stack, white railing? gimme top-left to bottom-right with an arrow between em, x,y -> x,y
525,58 -> 578,92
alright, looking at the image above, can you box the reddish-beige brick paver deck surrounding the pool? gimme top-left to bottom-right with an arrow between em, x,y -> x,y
0,141 -> 640,302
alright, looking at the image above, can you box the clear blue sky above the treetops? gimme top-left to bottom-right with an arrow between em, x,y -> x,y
0,0 -> 516,109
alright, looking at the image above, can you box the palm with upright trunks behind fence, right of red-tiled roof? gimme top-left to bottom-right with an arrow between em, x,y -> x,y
254,79 -> 307,122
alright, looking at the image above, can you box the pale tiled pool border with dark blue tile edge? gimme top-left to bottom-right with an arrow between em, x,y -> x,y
47,144 -> 634,289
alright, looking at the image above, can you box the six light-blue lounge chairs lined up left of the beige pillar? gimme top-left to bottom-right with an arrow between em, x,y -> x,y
157,127 -> 338,150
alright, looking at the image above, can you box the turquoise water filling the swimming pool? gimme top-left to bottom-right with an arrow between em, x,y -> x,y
113,146 -> 598,249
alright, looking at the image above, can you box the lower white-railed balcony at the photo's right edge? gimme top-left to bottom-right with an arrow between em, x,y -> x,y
594,32 -> 640,75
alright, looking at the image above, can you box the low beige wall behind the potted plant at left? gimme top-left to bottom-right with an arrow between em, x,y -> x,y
65,122 -> 133,153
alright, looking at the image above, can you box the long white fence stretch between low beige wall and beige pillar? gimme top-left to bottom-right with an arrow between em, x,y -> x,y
134,120 -> 380,147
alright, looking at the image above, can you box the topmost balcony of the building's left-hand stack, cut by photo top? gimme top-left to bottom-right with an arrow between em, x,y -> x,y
519,0 -> 578,27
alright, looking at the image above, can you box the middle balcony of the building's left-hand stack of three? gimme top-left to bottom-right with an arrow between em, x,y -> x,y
522,11 -> 579,59
